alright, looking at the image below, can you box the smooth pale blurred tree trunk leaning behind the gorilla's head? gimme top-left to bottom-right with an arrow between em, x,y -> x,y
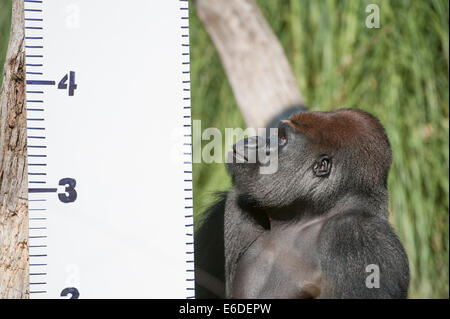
195,0 -> 304,128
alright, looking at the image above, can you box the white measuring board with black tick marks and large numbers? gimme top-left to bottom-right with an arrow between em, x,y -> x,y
24,0 -> 195,298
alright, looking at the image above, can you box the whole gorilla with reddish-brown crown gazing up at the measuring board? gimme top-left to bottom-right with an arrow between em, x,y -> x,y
195,109 -> 409,298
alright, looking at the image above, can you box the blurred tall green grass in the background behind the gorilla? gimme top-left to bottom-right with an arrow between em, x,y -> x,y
0,0 -> 449,298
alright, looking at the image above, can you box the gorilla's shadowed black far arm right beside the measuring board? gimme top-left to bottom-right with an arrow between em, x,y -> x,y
194,193 -> 227,298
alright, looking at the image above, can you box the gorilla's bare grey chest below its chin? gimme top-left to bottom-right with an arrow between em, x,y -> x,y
232,220 -> 321,298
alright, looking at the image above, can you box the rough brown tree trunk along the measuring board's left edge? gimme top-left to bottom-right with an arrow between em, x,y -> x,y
0,0 -> 29,298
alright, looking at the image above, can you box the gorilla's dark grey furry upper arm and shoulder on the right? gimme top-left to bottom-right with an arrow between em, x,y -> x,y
318,211 -> 409,298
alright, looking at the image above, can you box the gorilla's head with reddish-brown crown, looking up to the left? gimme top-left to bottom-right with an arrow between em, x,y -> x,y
228,109 -> 392,208
